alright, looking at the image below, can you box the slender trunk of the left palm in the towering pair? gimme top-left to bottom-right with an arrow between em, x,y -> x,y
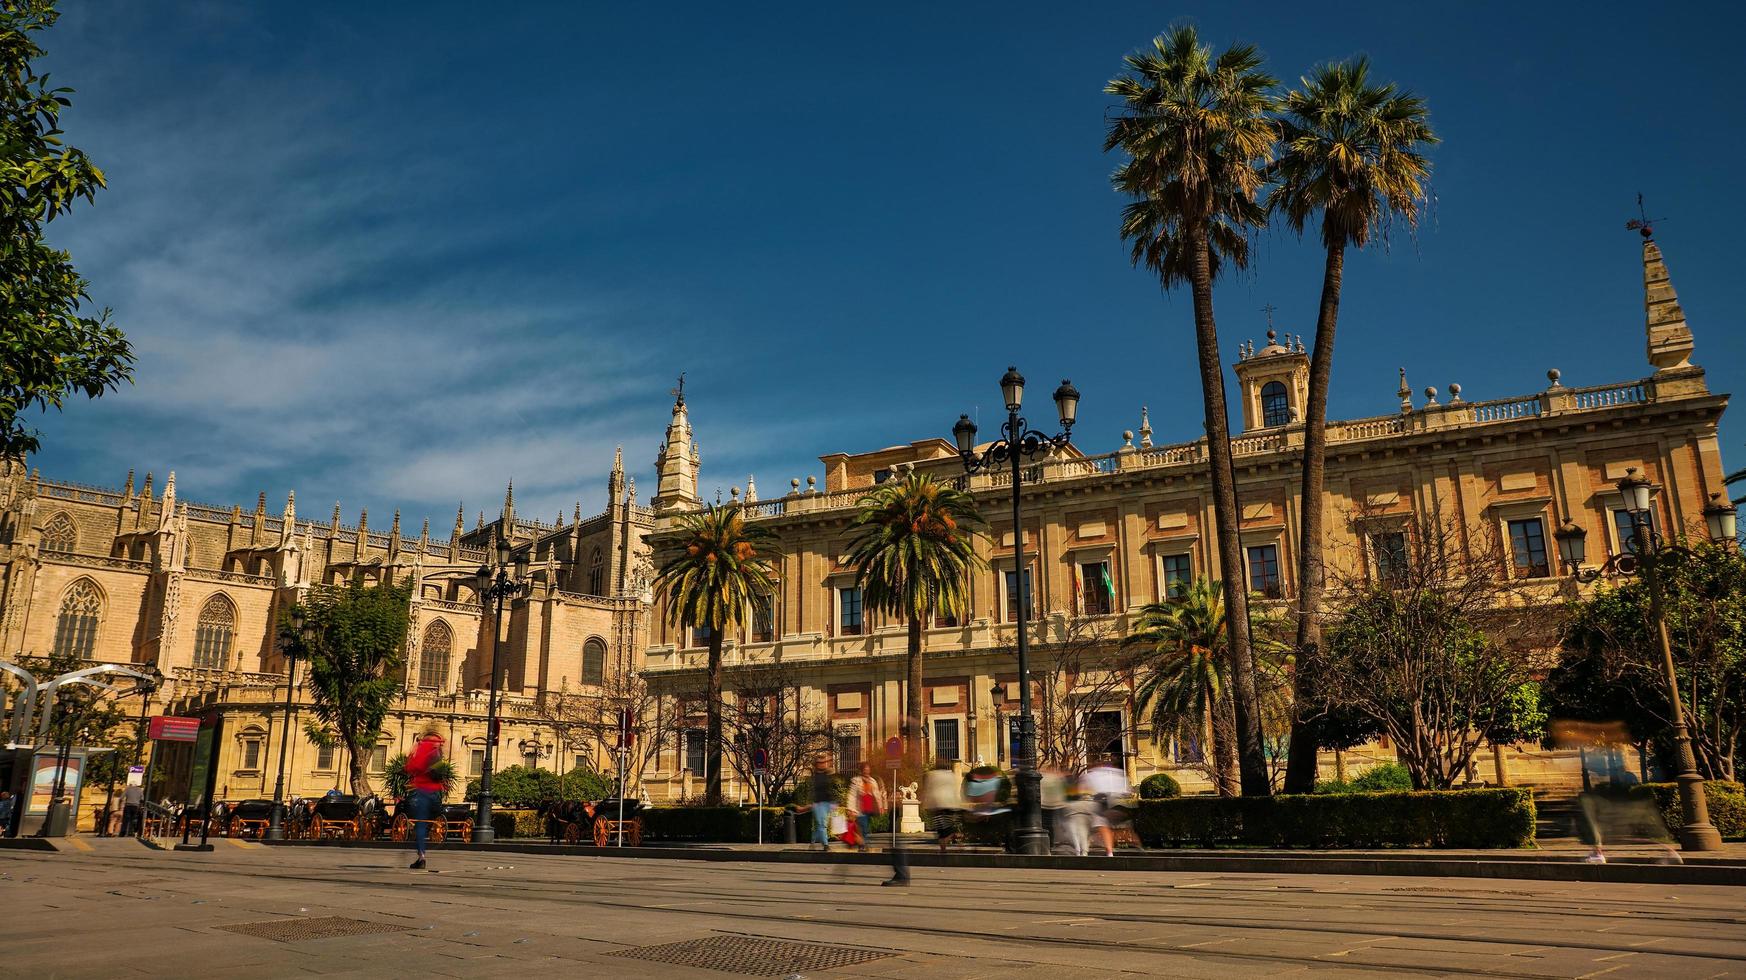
1187,217 -> 1271,797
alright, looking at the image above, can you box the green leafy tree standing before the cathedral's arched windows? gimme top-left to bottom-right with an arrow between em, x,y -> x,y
298,578 -> 412,797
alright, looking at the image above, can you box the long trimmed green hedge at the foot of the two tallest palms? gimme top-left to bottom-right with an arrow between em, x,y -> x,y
1135,790 -> 1535,847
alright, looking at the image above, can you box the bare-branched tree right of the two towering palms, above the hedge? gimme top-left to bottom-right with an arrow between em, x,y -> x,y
1316,503 -> 1545,790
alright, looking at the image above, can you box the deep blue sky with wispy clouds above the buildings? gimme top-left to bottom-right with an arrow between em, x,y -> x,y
37,0 -> 1746,533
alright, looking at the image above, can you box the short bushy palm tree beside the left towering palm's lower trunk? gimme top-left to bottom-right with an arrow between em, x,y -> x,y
1123,578 -> 1236,797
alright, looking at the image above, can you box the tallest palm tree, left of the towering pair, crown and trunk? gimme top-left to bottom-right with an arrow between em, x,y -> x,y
1103,26 -> 1278,797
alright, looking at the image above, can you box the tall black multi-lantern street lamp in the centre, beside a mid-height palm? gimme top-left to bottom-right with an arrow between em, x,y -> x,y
952,367 -> 1079,854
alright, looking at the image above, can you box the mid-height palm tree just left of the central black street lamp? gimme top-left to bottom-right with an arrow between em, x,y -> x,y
847,472 -> 985,767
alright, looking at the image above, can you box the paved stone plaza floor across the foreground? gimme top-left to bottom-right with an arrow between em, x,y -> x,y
0,840 -> 1746,980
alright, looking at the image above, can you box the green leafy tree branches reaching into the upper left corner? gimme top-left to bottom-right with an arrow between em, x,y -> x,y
0,0 -> 133,456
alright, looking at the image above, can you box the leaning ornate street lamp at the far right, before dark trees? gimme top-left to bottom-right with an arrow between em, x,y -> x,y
1552,466 -> 1736,851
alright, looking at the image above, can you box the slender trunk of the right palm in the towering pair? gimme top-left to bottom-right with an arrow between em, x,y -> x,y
1285,245 -> 1346,793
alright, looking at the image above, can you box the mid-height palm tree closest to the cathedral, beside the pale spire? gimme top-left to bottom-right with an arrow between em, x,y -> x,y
655,505 -> 782,805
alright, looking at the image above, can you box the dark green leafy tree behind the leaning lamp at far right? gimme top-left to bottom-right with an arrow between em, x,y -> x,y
1550,543 -> 1746,779
